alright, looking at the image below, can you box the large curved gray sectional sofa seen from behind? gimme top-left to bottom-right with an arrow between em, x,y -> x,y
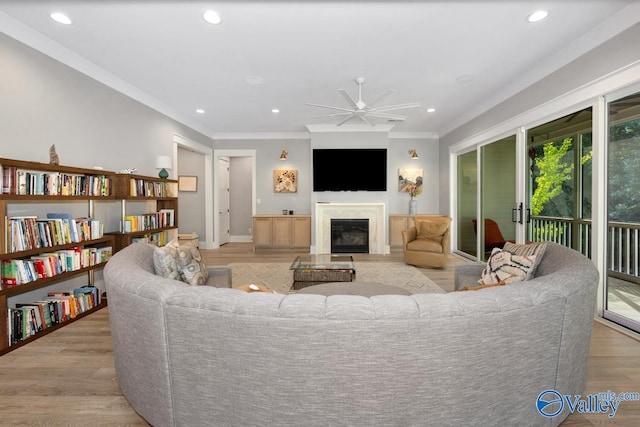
105,244 -> 598,427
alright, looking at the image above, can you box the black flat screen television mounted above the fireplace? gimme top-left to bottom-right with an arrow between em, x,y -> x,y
313,148 -> 387,191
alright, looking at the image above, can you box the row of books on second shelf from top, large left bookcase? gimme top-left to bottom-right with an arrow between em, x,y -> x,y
5,213 -> 104,253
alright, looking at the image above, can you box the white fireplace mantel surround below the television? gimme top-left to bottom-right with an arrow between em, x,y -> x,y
315,203 -> 385,254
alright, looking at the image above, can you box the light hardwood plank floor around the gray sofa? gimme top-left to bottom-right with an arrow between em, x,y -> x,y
0,243 -> 640,426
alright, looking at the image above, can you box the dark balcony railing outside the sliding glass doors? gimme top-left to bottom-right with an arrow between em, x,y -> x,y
529,216 -> 640,283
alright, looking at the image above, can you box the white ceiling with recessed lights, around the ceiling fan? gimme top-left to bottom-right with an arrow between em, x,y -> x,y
0,0 -> 640,138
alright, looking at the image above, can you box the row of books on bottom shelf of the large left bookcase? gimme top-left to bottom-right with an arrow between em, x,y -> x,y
7,286 -> 102,346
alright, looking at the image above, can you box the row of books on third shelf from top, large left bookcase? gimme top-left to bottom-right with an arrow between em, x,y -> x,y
1,246 -> 113,286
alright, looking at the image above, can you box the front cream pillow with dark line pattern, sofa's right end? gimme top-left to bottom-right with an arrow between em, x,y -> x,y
478,248 -> 536,285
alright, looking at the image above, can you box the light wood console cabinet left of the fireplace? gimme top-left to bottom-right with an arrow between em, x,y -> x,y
253,215 -> 311,250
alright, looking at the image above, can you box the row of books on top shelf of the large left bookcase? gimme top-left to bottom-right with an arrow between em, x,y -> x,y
0,165 -> 111,196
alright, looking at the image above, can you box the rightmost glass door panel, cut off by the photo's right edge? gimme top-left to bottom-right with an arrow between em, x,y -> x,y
604,92 -> 640,331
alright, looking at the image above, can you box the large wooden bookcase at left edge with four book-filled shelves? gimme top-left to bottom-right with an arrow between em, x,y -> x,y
0,158 -> 115,355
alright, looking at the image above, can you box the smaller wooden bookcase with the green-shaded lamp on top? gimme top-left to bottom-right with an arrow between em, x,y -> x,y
107,174 -> 178,253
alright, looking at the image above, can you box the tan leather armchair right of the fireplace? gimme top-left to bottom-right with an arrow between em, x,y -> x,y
402,215 -> 451,268
